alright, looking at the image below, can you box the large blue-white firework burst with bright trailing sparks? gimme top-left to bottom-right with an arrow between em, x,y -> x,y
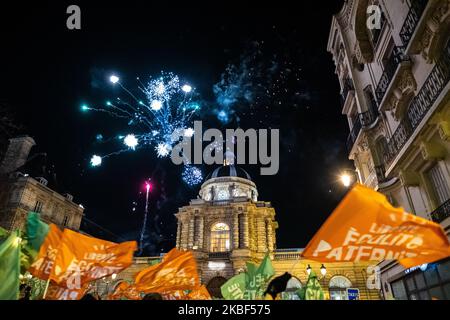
81,72 -> 200,166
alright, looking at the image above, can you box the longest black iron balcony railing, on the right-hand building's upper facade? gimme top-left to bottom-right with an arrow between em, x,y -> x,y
384,41 -> 450,167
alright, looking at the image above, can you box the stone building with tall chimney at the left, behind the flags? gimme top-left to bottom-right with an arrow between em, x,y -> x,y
0,136 -> 84,231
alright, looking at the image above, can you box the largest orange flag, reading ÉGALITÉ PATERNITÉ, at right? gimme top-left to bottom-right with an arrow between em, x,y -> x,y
302,185 -> 450,268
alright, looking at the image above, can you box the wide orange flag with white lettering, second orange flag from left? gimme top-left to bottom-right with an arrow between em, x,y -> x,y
50,229 -> 137,289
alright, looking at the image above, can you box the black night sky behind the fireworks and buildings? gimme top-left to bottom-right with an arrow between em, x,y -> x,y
0,1 -> 351,254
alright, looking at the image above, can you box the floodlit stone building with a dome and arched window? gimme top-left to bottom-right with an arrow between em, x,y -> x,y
114,165 -> 380,300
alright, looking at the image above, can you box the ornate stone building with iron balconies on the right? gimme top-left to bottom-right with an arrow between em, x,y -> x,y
328,0 -> 450,299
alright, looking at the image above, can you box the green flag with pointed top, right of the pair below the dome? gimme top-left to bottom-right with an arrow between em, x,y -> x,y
244,254 -> 275,300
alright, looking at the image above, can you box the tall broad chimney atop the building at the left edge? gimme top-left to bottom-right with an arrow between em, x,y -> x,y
0,136 -> 36,174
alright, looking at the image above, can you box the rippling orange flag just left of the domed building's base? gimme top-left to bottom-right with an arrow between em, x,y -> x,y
134,249 -> 200,293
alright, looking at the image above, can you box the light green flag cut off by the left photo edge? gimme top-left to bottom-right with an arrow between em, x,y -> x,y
0,231 -> 21,300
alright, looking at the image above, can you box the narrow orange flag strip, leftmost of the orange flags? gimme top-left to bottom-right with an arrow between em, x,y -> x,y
28,223 -> 62,280
